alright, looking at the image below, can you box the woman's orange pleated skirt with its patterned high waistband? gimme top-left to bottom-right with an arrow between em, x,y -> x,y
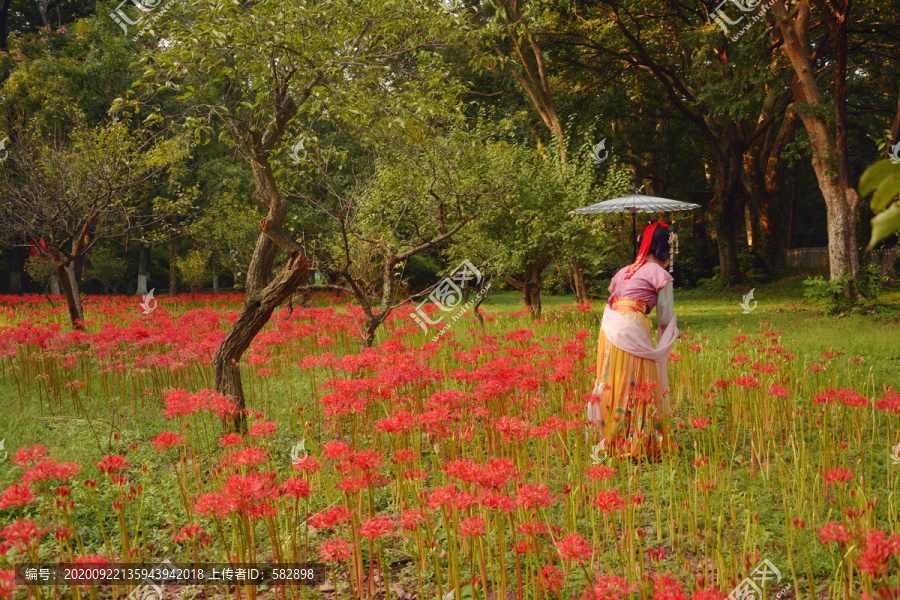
587,298 -> 672,460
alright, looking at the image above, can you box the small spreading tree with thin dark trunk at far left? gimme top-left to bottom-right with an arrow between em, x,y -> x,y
0,122 -> 190,329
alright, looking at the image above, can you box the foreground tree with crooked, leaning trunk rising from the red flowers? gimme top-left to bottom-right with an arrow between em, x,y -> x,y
142,0 -> 472,422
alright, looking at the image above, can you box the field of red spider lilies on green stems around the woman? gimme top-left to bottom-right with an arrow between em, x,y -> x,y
0,294 -> 900,600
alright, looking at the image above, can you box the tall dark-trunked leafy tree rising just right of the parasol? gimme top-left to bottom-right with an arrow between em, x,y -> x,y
548,0 -> 788,284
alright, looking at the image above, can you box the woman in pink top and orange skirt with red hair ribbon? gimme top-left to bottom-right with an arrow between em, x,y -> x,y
587,222 -> 678,460
